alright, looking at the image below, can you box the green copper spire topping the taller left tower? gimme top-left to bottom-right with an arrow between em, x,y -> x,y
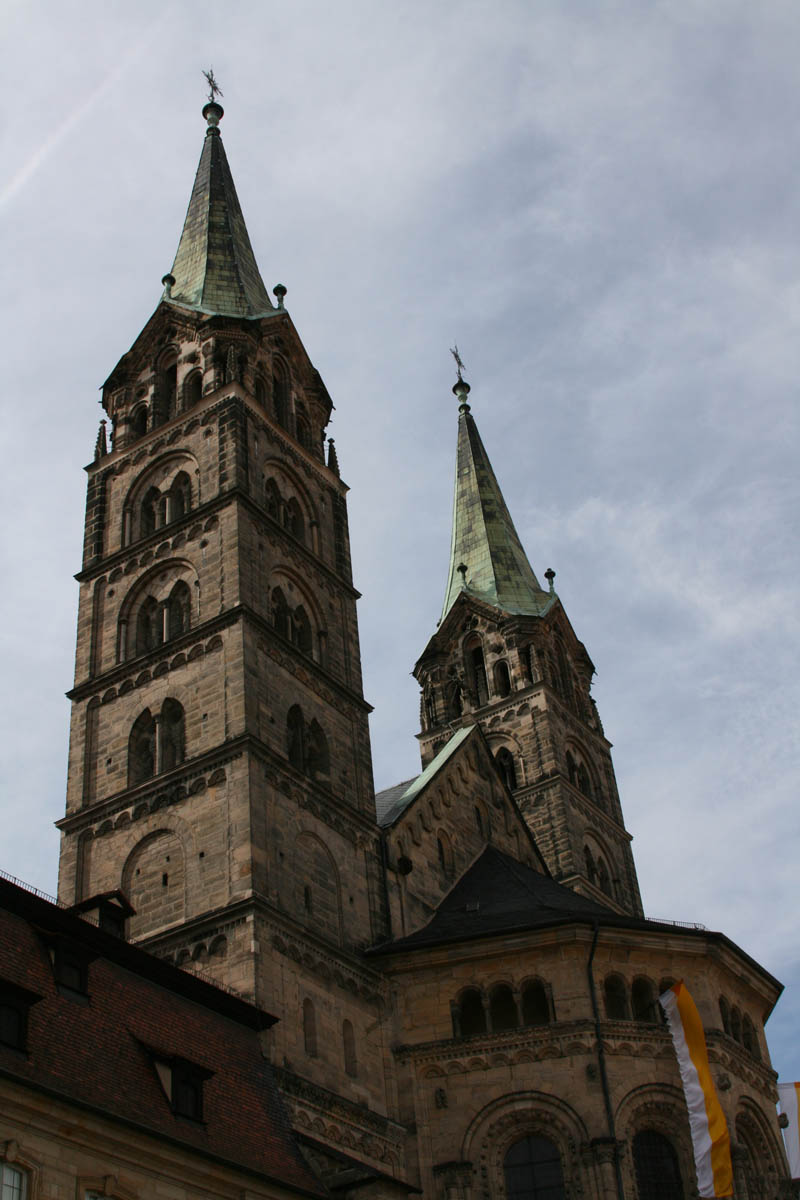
164,98 -> 275,317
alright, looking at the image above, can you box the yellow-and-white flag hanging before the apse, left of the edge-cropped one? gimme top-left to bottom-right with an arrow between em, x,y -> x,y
658,979 -> 733,1198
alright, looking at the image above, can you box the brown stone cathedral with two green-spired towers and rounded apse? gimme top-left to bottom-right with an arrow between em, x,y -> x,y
29,101 -> 788,1200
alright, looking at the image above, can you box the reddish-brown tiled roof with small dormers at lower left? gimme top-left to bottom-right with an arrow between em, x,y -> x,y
0,878 -> 324,1196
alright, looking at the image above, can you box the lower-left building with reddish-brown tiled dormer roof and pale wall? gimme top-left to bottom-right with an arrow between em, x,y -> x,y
0,878 -> 325,1200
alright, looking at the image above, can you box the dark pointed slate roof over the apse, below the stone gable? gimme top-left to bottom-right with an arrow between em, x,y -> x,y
371,846 -> 618,953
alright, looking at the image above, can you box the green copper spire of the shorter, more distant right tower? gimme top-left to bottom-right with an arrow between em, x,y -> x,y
441,372 -> 551,620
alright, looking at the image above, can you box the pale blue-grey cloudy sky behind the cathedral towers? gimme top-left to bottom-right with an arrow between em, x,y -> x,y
0,0 -> 800,1079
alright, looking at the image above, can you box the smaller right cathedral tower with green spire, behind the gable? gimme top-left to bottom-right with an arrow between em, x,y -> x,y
414,371 -> 642,916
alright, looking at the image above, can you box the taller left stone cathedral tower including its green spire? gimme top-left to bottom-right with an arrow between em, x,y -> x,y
53,98 -> 398,1141
